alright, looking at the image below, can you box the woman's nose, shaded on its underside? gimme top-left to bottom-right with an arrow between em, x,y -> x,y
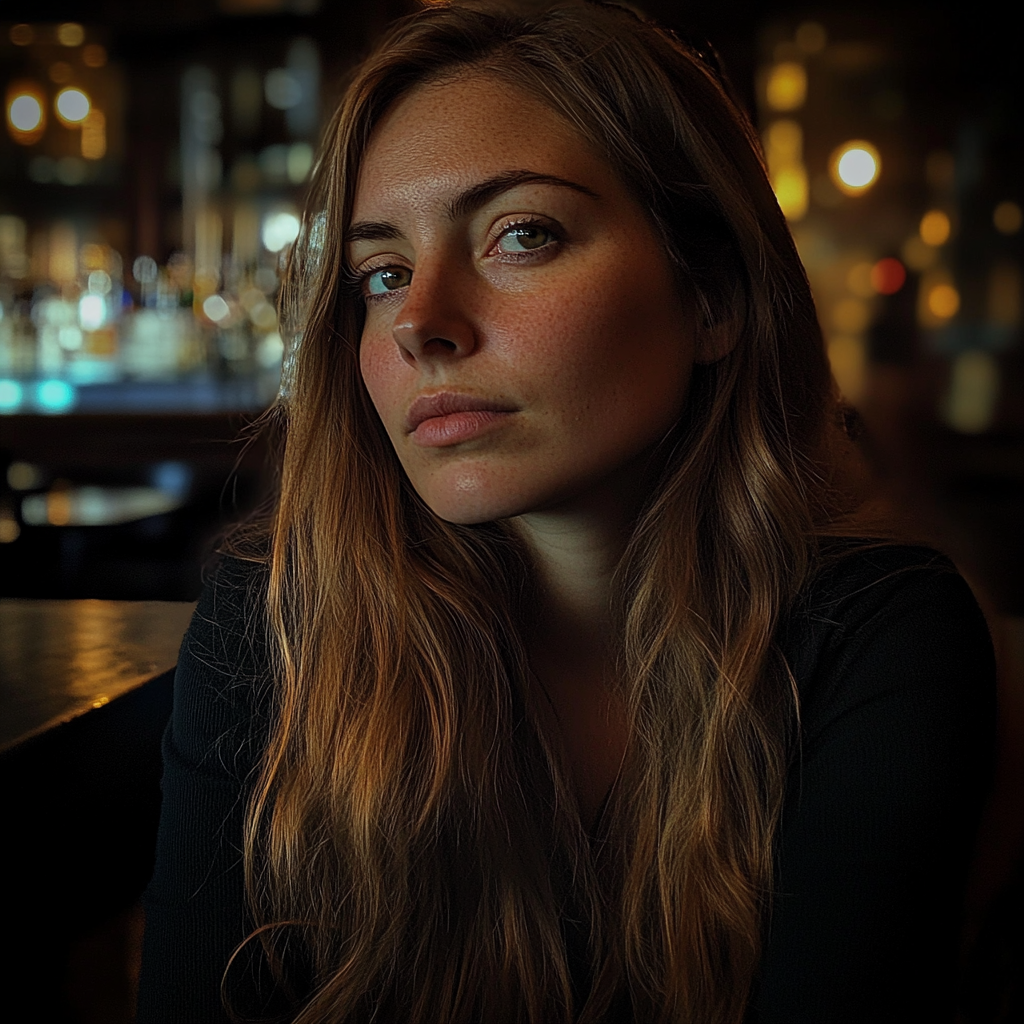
391,261 -> 477,366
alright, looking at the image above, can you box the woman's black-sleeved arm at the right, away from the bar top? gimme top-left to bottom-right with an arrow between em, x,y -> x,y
749,549 -> 994,1024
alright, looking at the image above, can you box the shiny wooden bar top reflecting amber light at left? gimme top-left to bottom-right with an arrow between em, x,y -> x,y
0,599 -> 195,751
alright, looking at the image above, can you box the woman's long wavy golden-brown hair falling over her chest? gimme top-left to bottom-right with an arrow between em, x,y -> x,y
239,3 -> 864,1024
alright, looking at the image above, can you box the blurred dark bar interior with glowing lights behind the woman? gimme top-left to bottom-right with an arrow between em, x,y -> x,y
0,0 -> 1024,1021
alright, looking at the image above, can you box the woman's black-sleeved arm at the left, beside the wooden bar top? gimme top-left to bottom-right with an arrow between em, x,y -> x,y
137,559 -> 265,1024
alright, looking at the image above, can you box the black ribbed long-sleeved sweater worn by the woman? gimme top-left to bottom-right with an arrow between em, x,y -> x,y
138,547 -> 994,1024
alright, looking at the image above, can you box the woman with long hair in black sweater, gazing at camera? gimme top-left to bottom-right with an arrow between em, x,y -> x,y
140,4 -> 992,1024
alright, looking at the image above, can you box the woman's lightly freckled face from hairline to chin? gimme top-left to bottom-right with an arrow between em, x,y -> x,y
347,75 -> 694,523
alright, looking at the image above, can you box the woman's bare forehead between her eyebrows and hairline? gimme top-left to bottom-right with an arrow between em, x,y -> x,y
353,73 -> 613,220
